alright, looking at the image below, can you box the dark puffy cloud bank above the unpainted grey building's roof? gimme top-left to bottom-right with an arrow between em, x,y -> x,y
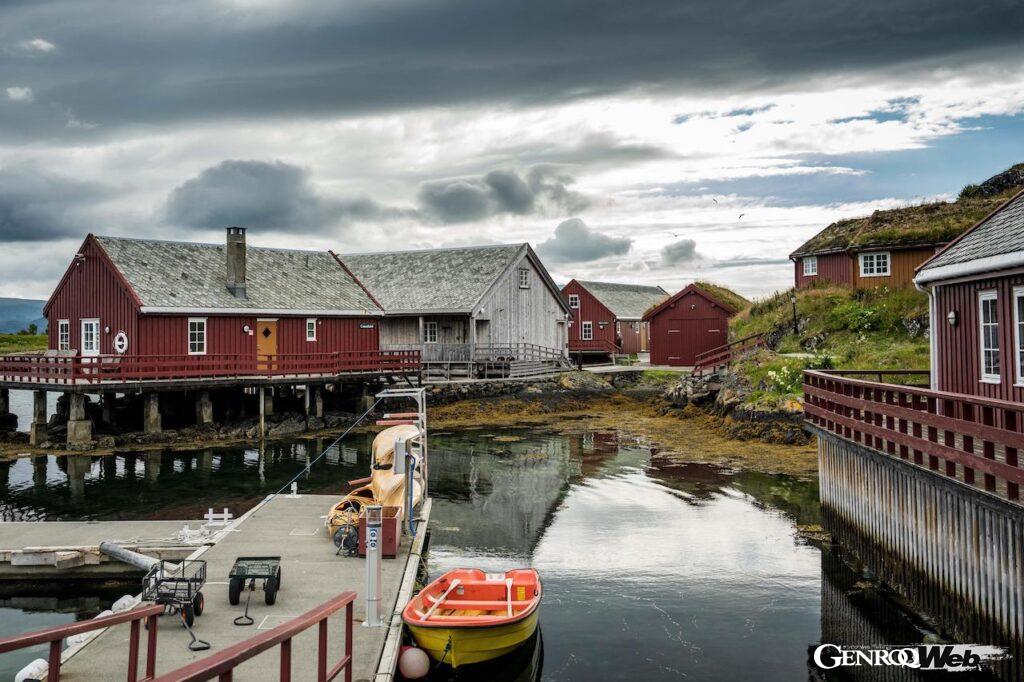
419,166 -> 588,223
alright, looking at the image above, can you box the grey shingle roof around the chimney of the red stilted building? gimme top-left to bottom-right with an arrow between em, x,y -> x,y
96,237 -> 380,314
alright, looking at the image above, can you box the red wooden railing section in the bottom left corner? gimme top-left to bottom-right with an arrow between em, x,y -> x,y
0,605 -> 164,682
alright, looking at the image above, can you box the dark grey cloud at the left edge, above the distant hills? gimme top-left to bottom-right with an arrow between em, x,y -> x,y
0,167 -> 112,242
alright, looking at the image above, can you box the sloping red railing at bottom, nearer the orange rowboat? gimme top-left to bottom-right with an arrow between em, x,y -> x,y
151,592 -> 355,682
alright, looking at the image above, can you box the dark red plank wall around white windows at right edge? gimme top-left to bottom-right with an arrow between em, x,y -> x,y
934,274 -> 1024,402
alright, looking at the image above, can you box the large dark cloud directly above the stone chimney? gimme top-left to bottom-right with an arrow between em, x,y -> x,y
164,161 -> 392,232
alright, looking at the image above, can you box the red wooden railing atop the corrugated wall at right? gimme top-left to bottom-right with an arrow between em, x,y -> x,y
804,370 -> 1024,502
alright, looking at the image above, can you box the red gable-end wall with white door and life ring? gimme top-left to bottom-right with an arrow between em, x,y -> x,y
46,239 -> 138,353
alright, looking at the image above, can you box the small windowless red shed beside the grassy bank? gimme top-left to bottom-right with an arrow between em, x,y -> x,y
643,284 -> 738,367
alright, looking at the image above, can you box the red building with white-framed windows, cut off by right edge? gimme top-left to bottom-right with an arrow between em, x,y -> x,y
914,186 -> 1024,402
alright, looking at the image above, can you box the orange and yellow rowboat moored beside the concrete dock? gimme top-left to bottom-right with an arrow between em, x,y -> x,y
401,568 -> 541,668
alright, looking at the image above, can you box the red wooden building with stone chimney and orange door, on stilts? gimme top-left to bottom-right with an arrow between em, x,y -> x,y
44,227 -> 382,369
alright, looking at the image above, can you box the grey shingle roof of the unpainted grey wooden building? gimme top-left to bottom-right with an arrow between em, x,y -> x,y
338,244 -> 525,313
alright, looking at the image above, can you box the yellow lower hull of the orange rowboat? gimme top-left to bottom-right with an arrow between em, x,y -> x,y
407,609 -> 539,668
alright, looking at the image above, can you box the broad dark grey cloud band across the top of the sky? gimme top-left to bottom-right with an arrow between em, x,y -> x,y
0,0 -> 1024,139
